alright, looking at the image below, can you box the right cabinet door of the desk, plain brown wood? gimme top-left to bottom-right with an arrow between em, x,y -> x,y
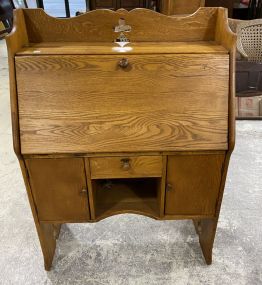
165,154 -> 225,215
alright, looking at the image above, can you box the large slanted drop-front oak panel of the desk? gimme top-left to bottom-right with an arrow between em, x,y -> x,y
16,54 -> 229,154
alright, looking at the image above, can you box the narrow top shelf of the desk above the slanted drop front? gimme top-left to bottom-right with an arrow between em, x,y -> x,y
16,41 -> 228,56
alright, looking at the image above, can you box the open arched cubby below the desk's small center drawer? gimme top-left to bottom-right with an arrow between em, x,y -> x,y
92,178 -> 161,218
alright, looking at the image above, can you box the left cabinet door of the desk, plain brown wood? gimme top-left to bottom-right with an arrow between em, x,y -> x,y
26,158 -> 89,222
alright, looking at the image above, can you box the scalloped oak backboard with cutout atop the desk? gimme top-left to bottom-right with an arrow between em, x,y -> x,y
23,8 -> 218,43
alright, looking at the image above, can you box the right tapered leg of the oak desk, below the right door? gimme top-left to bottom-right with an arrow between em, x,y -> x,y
193,218 -> 218,265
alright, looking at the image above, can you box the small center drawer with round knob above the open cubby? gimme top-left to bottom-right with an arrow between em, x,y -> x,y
90,156 -> 162,179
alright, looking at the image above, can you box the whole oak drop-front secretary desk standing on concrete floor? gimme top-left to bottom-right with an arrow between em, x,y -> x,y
7,8 -> 236,270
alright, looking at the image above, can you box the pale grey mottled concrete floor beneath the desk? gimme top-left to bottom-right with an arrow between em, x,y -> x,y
0,41 -> 262,285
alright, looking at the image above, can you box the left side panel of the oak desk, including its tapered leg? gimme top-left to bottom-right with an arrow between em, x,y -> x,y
6,10 -> 60,270
